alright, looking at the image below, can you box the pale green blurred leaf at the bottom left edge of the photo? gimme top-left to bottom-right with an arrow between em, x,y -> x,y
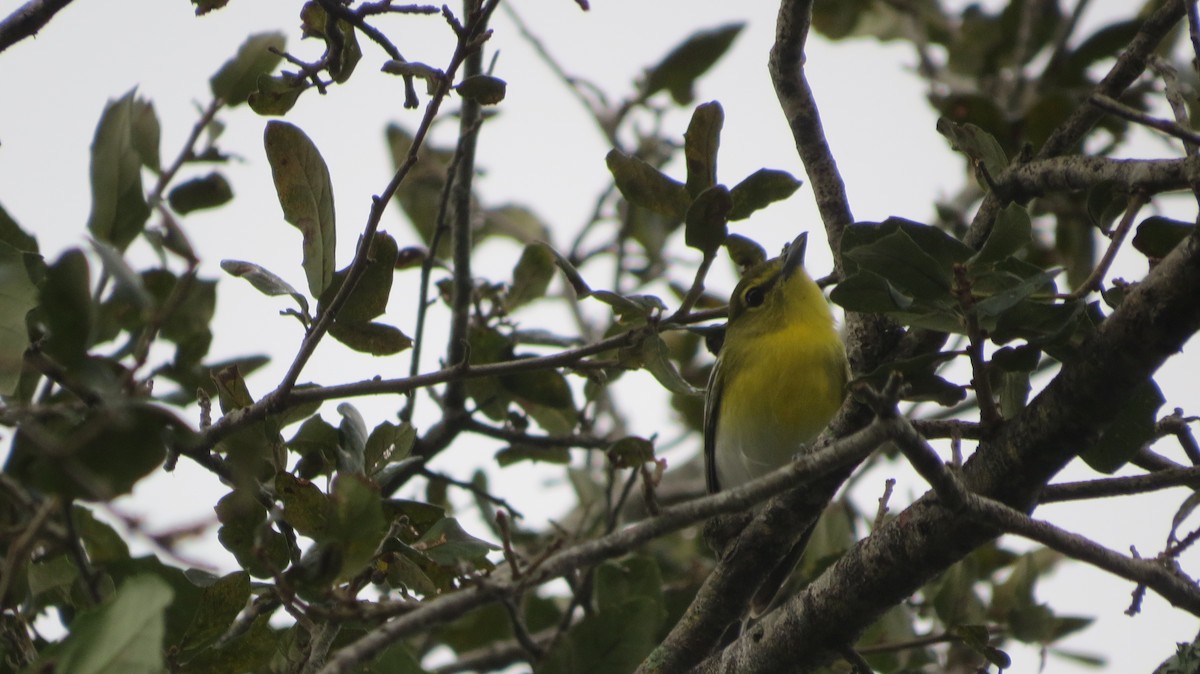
54,576 -> 173,674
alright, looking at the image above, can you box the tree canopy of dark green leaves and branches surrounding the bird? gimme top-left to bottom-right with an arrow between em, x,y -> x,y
0,0 -> 1200,674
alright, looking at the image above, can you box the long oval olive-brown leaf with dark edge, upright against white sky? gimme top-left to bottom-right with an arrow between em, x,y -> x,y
263,121 -> 336,297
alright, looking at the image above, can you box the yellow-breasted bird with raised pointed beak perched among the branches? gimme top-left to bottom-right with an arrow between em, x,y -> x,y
703,233 -> 850,616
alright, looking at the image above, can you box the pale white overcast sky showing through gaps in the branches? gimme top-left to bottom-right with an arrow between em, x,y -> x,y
0,0 -> 1198,673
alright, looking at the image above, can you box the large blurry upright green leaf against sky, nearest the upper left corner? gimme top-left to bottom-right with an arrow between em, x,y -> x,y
88,90 -> 150,251
